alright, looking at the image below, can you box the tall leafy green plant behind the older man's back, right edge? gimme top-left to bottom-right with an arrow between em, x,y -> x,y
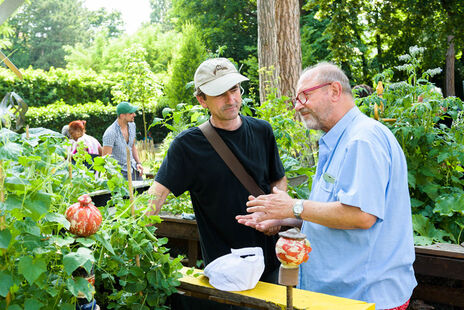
357,47 -> 464,245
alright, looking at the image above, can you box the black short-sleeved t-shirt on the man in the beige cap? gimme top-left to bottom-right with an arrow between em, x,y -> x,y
155,116 -> 285,274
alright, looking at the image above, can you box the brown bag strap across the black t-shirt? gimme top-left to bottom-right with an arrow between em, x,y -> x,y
198,121 -> 264,197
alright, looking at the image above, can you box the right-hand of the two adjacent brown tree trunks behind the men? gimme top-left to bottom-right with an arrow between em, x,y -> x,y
276,0 -> 301,98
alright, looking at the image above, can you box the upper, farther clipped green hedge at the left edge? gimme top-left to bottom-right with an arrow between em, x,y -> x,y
0,68 -> 121,107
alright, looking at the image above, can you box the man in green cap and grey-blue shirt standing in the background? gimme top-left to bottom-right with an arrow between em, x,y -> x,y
103,101 -> 143,181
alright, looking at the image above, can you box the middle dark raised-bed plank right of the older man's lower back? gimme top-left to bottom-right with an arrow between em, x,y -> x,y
414,254 -> 464,280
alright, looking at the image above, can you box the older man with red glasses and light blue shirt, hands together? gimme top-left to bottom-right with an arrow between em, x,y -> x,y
237,63 -> 417,309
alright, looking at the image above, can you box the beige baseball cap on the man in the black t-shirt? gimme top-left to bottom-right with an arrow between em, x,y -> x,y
193,58 -> 249,96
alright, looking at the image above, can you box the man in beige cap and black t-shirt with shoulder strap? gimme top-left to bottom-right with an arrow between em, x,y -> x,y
149,58 -> 287,290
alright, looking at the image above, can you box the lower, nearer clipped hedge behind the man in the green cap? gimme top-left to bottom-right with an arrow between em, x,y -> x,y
26,100 -> 168,143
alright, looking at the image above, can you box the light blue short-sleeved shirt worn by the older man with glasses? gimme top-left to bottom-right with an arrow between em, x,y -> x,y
299,107 -> 417,309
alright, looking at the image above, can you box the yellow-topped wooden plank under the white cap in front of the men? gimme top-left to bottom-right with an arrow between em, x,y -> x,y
179,267 -> 375,310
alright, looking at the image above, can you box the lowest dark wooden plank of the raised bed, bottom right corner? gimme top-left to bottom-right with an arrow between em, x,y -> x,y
412,284 -> 464,307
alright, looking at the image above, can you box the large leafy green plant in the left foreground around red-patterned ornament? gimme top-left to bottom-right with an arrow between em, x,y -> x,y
0,128 -> 181,310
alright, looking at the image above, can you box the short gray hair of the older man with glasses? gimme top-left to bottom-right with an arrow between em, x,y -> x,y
300,62 -> 351,95
